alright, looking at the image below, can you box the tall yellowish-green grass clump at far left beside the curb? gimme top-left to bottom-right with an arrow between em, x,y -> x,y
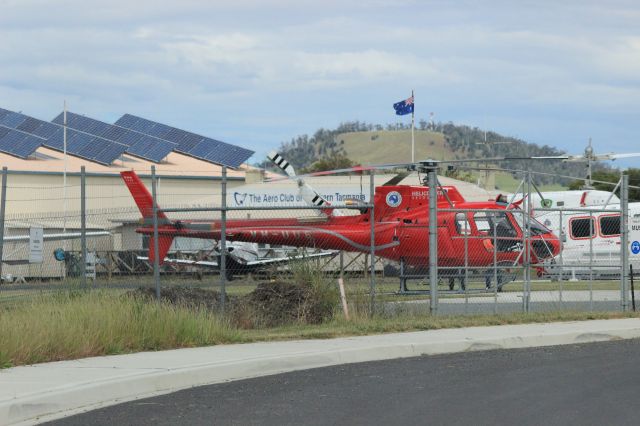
0,291 -> 241,367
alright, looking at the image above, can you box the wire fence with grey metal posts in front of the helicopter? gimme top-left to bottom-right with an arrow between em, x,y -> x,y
0,168 -> 640,314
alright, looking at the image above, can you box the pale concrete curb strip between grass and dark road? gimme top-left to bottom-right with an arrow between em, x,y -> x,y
0,318 -> 640,425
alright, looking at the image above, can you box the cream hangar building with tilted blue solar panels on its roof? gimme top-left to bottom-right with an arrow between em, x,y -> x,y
0,108 -> 253,277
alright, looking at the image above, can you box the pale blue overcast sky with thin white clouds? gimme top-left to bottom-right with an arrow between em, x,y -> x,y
0,0 -> 640,165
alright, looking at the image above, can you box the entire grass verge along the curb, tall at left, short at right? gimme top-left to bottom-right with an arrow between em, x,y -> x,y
0,290 -> 638,368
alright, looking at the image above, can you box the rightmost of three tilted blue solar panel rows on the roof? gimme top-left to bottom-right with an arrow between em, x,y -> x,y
115,114 -> 254,167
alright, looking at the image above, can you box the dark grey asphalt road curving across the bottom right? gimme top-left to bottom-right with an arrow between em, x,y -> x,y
48,340 -> 640,426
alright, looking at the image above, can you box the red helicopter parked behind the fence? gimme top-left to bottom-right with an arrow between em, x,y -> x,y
121,153 -> 560,276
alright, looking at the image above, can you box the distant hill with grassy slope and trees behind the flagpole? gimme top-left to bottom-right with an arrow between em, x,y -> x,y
263,121 -> 608,187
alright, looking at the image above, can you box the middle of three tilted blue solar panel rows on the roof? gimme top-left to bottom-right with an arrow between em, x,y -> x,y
53,112 -> 175,163
